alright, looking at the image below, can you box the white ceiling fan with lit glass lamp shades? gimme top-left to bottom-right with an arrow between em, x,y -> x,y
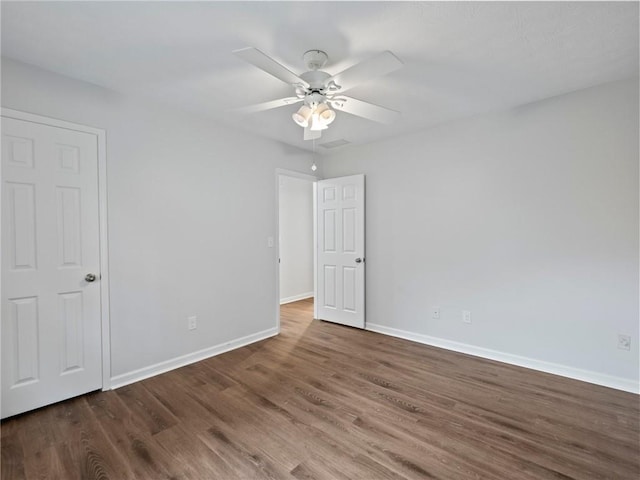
233,47 -> 403,140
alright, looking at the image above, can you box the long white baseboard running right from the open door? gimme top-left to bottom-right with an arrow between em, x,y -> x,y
365,323 -> 640,394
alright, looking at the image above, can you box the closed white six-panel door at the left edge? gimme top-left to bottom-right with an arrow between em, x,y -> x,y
2,117 -> 102,418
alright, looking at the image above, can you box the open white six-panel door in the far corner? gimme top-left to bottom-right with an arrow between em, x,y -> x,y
316,175 -> 365,328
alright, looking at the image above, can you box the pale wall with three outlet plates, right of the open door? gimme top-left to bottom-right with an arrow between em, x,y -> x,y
323,79 -> 640,390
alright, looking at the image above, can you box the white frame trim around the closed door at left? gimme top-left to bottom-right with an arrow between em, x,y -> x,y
0,107 -> 111,391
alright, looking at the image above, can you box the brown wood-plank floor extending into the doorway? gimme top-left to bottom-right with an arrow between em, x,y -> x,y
1,301 -> 640,480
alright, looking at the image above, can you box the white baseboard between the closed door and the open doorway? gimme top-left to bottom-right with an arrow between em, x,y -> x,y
111,327 -> 278,389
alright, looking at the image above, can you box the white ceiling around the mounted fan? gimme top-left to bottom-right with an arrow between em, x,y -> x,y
1,1 -> 638,150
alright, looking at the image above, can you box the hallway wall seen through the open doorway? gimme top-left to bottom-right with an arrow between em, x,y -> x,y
278,175 -> 313,303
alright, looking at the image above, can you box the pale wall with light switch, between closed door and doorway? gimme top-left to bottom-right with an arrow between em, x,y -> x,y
2,59 -> 310,383
